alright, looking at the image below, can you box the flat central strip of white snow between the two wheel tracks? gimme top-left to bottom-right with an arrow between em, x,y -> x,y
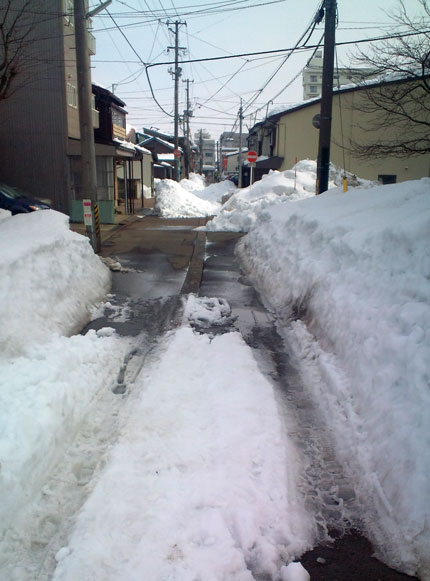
53,312 -> 314,581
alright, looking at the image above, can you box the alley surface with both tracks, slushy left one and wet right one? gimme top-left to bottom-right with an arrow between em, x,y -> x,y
0,215 -> 418,581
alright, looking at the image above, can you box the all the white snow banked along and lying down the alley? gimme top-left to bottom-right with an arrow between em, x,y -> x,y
0,161 -> 430,581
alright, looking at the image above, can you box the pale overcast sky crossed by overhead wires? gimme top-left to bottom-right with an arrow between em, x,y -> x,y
91,0 -> 422,139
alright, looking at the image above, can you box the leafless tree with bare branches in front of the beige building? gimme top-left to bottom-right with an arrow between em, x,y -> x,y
352,0 -> 430,158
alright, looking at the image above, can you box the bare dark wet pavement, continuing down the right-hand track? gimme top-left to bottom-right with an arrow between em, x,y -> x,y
85,216 -> 411,581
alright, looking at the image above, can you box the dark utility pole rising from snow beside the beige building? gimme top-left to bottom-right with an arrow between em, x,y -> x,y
316,0 -> 336,195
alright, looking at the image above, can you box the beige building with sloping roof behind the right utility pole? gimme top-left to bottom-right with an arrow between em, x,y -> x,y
249,79 -> 430,183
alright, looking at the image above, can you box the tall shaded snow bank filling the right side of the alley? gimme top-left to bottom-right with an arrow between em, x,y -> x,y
239,178 -> 430,579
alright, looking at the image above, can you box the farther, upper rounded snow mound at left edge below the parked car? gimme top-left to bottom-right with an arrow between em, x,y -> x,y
0,210 -> 110,357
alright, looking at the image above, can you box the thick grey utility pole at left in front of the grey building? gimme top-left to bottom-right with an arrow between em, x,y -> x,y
73,0 -> 112,252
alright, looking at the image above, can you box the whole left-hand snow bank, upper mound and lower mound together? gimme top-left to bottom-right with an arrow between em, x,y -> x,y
0,210 -> 126,542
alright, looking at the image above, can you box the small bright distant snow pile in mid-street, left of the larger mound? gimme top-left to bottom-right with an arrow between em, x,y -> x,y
155,174 -> 236,218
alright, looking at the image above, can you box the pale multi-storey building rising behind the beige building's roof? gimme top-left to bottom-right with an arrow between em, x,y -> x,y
302,50 -> 373,100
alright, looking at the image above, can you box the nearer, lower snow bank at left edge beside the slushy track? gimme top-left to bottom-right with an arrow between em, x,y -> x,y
0,326 -> 126,538
